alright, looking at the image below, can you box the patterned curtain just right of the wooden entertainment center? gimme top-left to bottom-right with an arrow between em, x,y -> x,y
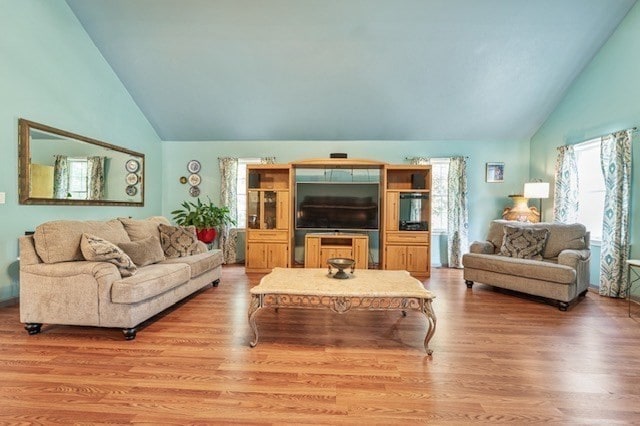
447,157 -> 469,268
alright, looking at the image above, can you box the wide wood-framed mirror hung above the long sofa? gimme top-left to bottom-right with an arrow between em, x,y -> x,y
18,118 -> 144,206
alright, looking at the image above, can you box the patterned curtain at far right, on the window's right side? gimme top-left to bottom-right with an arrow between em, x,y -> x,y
600,130 -> 631,297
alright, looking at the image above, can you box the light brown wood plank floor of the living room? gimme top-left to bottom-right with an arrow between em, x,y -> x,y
0,266 -> 640,425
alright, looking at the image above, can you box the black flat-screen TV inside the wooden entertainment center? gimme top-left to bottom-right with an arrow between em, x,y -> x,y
296,182 -> 380,231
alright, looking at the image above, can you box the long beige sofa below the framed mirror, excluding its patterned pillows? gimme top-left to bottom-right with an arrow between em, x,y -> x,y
20,217 -> 223,340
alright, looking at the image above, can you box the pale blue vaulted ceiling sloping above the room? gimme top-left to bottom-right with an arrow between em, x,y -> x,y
67,0 -> 635,141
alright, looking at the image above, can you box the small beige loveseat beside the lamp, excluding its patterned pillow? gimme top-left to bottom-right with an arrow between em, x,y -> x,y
462,220 -> 591,311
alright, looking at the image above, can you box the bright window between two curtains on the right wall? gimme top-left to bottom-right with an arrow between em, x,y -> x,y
574,138 -> 605,241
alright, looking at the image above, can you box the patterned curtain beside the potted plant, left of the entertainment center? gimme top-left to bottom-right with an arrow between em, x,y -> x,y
218,157 -> 238,263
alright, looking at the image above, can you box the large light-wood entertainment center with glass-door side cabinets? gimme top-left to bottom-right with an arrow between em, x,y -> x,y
246,158 -> 431,277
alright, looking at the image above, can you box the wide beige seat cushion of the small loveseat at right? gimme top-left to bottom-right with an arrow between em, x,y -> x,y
463,253 -> 576,284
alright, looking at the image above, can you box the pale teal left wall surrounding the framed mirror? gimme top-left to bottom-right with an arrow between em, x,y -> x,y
0,0 -> 162,302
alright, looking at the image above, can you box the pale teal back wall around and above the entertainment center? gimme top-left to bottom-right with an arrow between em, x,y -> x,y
162,141 -> 529,262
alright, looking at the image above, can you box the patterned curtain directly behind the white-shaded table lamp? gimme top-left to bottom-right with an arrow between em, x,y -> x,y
553,145 -> 578,223
